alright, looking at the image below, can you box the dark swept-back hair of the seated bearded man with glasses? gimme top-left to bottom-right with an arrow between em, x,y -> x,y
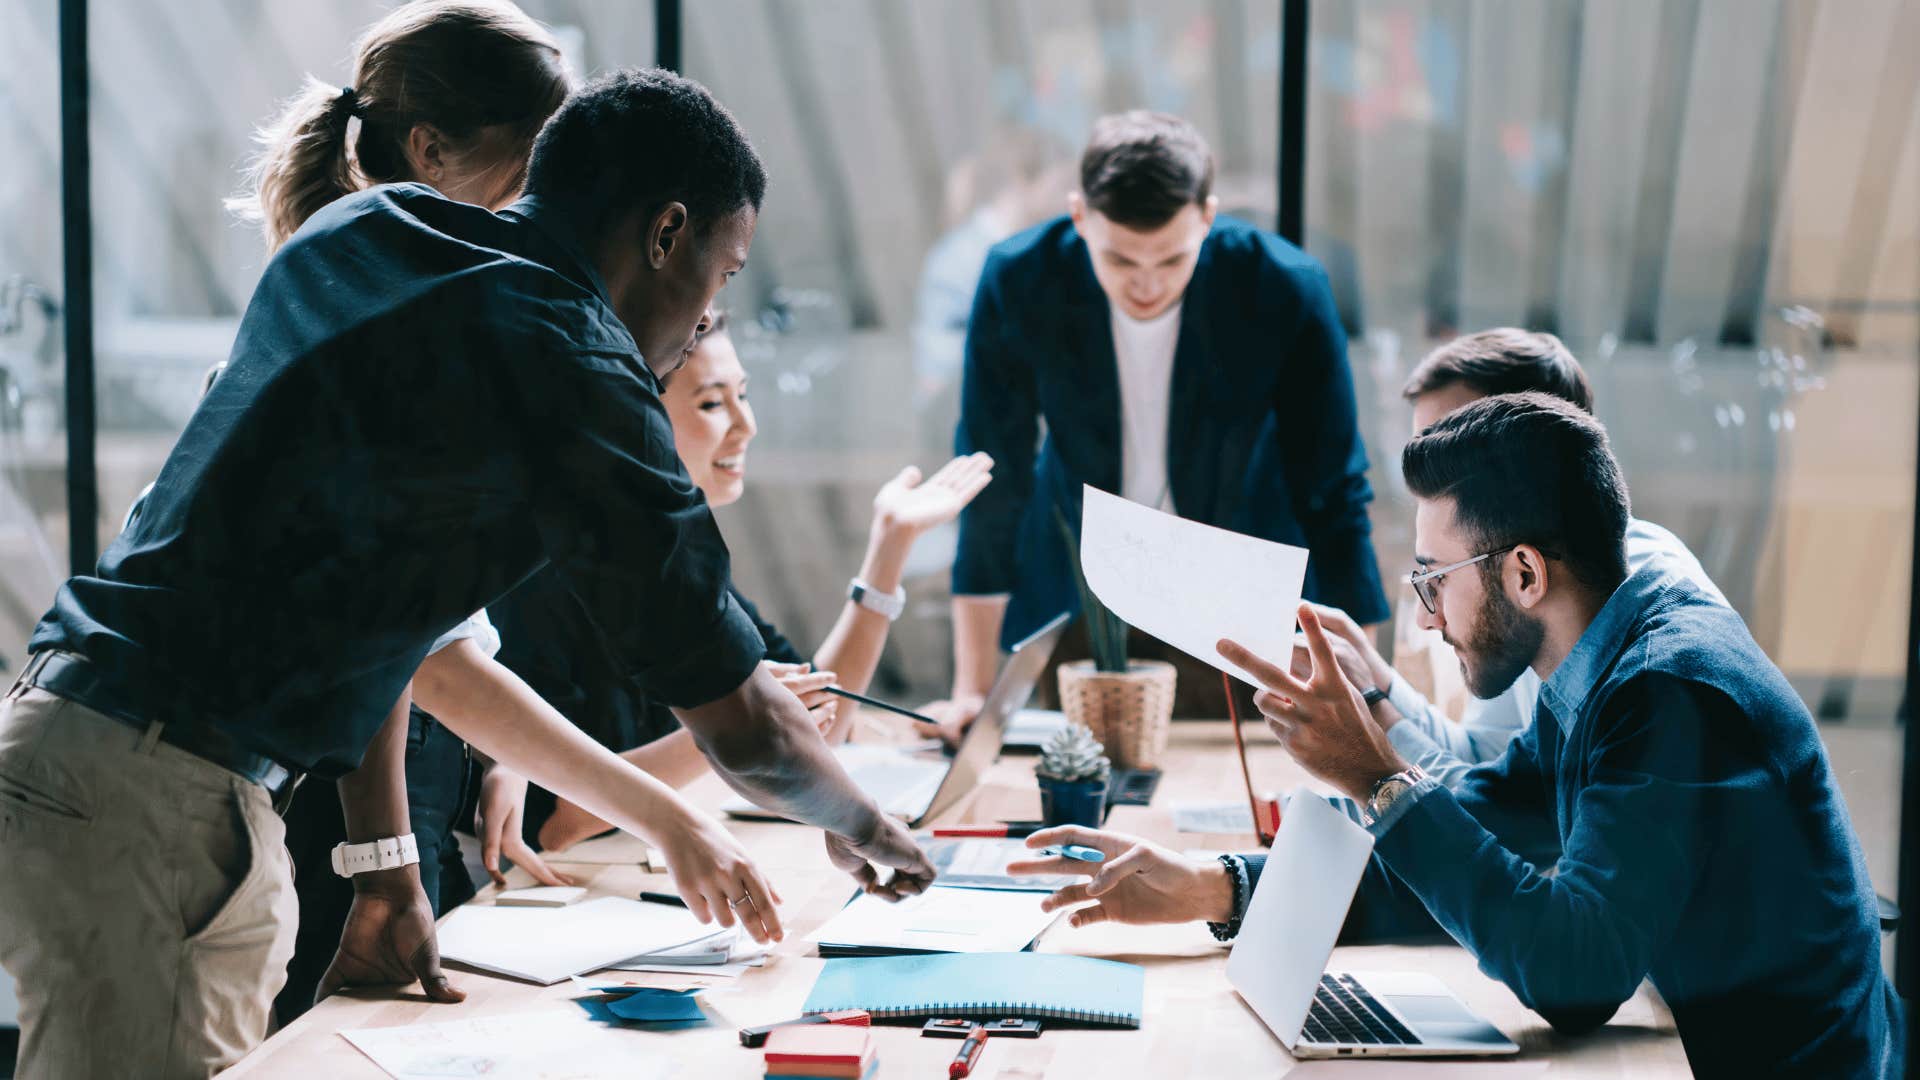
1400,392 -> 1630,596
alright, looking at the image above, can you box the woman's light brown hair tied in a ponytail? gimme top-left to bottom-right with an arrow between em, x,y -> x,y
227,0 -> 570,250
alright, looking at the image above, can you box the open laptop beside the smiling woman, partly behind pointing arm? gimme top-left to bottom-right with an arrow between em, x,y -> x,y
720,615 -> 1068,828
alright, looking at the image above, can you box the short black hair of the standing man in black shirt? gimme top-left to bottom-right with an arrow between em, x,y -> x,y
526,67 -> 766,229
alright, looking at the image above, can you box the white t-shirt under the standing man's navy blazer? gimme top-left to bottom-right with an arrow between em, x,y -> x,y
1114,304 -> 1181,513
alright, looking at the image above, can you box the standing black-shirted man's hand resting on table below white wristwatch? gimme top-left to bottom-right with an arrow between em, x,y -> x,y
313,867 -> 467,1003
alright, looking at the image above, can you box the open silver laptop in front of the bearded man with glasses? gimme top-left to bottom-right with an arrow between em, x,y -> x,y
1227,792 -> 1521,1057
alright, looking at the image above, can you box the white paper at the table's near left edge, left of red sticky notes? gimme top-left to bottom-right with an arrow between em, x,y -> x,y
340,1007 -> 678,1080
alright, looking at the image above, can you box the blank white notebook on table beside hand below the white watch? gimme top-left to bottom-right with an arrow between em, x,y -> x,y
440,896 -> 726,986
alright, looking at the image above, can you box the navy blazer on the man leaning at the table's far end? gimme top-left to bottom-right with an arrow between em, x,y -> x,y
952,217 -> 1388,644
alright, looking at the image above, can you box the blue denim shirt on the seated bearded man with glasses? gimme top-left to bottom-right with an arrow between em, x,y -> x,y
1248,565 -> 1901,1076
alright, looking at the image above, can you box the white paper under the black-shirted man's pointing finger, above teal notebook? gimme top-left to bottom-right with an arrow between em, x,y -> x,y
806,886 -> 1060,953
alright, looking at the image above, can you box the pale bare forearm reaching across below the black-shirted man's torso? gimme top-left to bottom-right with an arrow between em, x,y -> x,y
413,642 -> 697,846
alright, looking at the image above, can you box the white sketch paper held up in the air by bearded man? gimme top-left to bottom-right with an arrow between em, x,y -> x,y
1081,486 -> 1308,686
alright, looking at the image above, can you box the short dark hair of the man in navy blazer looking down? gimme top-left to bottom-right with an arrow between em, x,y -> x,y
1081,110 -> 1213,229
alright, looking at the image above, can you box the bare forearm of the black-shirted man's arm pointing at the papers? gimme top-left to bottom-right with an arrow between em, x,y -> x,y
674,665 -> 881,842
